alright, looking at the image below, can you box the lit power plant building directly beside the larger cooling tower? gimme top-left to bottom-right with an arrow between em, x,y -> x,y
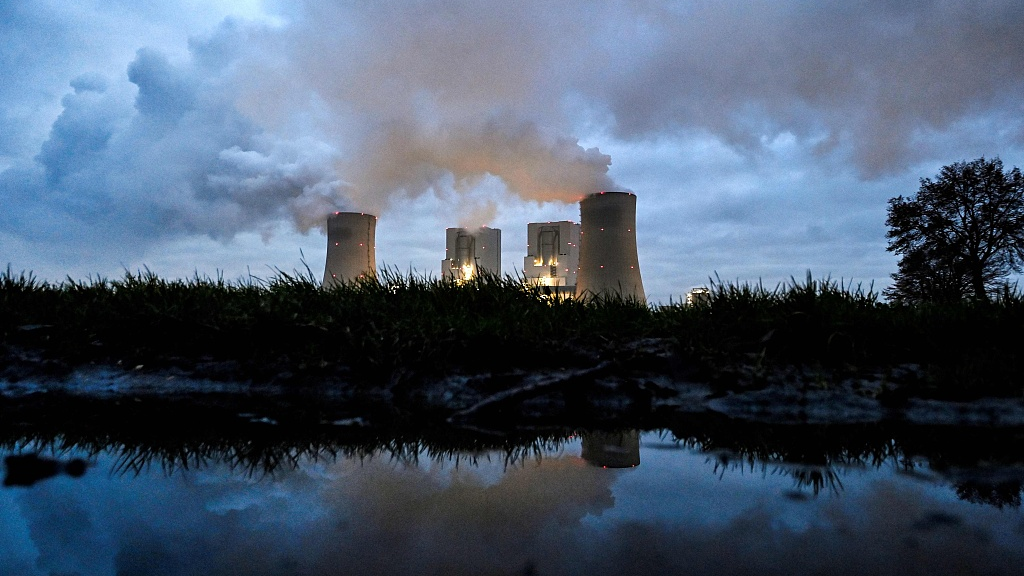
522,220 -> 580,295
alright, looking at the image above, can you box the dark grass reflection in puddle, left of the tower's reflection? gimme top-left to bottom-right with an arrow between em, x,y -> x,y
0,426 -> 574,480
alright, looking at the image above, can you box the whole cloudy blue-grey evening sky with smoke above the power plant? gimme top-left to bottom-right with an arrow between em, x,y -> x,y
0,0 -> 1024,302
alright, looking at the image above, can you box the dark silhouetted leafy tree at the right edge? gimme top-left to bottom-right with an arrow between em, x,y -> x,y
885,158 -> 1024,301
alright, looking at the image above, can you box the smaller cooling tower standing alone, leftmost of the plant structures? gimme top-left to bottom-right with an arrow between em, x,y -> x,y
324,212 -> 377,288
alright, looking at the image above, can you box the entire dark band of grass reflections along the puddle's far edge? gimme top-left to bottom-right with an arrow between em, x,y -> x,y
0,417 -> 1024,508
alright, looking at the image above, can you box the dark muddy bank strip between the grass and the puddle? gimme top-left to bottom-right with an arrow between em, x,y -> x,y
0,334 -> 1024,429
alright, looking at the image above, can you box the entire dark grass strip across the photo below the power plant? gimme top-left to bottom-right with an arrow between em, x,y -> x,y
0,268 -> 1024,398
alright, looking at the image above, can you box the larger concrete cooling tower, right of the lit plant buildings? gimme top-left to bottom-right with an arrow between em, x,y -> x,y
575,192 -> 647,302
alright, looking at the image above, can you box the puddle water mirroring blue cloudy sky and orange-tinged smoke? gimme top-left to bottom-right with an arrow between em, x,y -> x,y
0,431 -> 1024,576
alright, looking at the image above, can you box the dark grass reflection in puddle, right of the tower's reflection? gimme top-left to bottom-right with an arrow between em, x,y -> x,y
668,415 -> 1024,502
